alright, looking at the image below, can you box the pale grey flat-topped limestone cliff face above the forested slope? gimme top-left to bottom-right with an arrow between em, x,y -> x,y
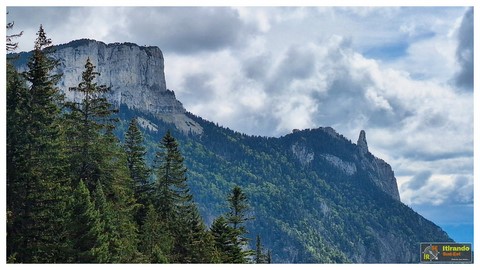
17,39 -> 202,133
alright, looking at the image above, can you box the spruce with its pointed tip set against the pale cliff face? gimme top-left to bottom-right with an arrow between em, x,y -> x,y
65,59 -> 118,193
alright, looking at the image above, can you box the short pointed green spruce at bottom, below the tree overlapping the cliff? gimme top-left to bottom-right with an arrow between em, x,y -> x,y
70,180 -> 109,263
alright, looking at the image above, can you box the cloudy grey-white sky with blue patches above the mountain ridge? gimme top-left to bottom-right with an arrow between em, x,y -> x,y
7,2 -> 473,241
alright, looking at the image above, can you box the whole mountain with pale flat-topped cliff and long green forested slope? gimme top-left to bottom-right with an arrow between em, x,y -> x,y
11,40 -> 452,263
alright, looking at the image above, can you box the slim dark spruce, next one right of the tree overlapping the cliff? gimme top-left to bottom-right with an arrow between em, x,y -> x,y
124,118 -> 153,225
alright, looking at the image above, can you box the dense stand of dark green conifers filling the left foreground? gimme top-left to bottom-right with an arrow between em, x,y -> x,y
6,27 -> 271,263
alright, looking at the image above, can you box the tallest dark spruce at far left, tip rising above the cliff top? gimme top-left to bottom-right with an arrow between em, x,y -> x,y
7,26 -> 70,262
